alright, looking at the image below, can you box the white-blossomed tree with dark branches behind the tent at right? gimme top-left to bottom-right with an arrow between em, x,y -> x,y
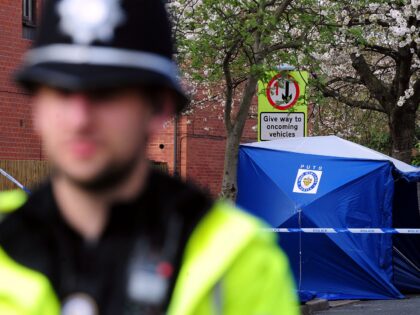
311,0 -> 420,163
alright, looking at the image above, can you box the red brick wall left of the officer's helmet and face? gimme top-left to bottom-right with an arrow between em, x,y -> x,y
0,0 -> 41,160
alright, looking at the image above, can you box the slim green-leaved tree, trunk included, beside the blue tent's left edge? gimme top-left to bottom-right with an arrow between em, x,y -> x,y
170,0 -> 324,199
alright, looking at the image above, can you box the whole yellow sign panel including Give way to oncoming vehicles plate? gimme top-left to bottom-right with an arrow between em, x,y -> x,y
258,71 -> 309,141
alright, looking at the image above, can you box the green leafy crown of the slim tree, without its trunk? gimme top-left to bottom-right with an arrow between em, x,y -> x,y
171,0 -> 319,86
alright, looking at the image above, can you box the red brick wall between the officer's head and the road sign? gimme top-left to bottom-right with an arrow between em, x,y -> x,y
149,99 -> 257,196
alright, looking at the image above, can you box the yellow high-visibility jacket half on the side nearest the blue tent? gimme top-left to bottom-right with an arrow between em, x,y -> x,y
168,202 -> 299,315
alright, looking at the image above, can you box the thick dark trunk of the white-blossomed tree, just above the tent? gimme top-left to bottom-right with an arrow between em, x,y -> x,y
389,104 -> 416,164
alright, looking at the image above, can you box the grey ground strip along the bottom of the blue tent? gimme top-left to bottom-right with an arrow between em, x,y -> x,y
301,295 -> 420,315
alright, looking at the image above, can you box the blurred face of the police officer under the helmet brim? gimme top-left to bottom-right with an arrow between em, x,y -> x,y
33,87 -> 167,189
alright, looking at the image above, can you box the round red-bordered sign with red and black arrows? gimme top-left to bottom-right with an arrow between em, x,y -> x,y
266,73 -> 300,110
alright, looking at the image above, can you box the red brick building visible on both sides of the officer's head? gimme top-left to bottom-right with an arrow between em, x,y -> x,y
0,0 -> 257,195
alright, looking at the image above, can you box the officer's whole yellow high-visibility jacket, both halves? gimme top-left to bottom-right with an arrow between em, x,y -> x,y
0,202 -> 299,315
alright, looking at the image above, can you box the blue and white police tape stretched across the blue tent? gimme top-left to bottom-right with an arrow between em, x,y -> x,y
263,228 -> 420,234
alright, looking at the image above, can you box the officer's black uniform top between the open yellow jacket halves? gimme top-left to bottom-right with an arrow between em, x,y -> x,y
0,171 -> 212,314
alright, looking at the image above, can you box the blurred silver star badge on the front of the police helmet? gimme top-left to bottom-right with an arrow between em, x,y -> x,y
57,0 -> 125,45
